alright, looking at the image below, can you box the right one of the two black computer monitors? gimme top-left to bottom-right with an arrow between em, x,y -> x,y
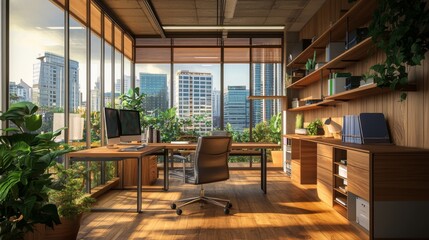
119,109 -> 142,142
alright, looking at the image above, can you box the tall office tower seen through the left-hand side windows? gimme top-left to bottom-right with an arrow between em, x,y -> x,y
33,52 -> 80,111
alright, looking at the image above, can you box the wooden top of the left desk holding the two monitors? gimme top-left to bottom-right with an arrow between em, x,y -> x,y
68,145 -> 164,158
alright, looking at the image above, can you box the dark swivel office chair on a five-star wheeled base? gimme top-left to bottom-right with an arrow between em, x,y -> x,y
171,136 -> 232,215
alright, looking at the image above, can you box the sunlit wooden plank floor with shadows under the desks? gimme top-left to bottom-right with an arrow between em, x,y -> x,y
78,170 -> 368,240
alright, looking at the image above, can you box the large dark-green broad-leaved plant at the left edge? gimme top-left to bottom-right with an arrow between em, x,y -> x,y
0,102 -> 71,239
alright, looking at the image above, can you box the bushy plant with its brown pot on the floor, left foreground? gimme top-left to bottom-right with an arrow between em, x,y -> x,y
43,163 -> 95,240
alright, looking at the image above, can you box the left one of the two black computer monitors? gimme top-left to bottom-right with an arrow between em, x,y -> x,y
104,108 -> 121,146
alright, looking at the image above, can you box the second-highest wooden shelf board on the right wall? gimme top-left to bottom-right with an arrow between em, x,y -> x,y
287,38 -> 373,88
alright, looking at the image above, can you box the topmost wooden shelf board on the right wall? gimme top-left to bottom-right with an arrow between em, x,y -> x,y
286,0 -> 376,68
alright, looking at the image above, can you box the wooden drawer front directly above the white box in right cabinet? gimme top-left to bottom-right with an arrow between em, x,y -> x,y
347,165 -> 369,201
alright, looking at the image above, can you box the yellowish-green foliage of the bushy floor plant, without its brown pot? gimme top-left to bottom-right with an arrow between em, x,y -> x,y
49,164 -> 95,219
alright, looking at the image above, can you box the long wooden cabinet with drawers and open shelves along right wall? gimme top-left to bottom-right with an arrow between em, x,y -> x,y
285,135 -> 429,239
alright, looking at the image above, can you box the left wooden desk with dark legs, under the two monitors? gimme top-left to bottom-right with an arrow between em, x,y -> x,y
67,145 -> 168,213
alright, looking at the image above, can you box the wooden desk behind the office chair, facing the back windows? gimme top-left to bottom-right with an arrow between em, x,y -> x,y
149,142 -> 280,194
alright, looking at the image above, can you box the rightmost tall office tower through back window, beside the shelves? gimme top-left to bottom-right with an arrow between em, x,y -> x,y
253,63 -> 281,125
